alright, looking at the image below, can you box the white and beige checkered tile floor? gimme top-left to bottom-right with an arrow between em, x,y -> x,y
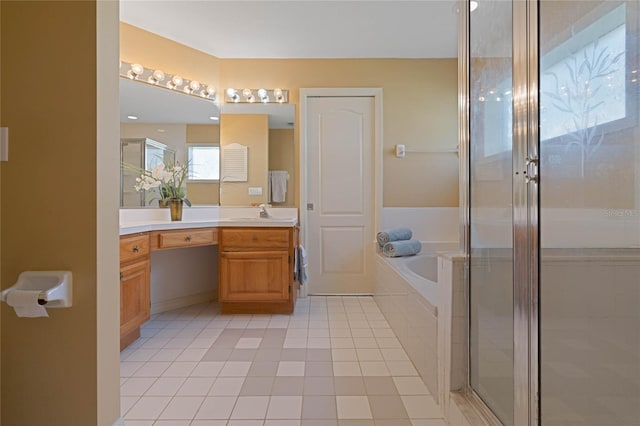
120,296 -> 446,426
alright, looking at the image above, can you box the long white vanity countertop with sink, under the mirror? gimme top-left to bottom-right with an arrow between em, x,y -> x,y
120,206 -> 298,235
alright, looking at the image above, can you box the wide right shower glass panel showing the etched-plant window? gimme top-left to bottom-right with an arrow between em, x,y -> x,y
540,0 -> 640,426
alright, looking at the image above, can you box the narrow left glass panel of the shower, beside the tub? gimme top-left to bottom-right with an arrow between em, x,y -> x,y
469,0 -> 514,425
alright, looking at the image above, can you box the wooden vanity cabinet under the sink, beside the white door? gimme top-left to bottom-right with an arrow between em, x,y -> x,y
218,227 -> 296,314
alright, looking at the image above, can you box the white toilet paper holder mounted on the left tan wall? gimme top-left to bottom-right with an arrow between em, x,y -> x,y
0,271 -> 73,308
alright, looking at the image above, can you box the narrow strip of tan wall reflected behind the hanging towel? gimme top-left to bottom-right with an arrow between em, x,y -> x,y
269,129 -> 296,207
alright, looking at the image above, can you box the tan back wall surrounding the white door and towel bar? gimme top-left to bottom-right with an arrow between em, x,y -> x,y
220,59 -> 458,207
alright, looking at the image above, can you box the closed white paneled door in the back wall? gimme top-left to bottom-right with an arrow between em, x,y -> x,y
303,97 -> 375,294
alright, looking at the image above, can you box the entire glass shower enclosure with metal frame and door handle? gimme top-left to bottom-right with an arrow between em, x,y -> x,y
465,0 -> 640,426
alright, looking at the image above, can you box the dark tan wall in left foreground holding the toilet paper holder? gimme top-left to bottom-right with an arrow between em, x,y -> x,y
0,1 -> 119,426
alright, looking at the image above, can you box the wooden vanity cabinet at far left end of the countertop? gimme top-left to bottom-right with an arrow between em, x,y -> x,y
120,233 -> 151,350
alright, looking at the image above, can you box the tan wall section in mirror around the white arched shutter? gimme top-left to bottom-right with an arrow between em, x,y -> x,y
220,114 -> 269,206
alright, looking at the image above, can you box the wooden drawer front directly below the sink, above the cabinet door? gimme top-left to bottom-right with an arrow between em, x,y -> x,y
221,228 -> 290,250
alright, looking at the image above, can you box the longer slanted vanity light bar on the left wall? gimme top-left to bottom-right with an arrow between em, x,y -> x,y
120,61 -> 217,102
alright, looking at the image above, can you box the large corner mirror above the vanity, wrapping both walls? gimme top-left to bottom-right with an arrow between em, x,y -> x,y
120,78 -> 295,208
